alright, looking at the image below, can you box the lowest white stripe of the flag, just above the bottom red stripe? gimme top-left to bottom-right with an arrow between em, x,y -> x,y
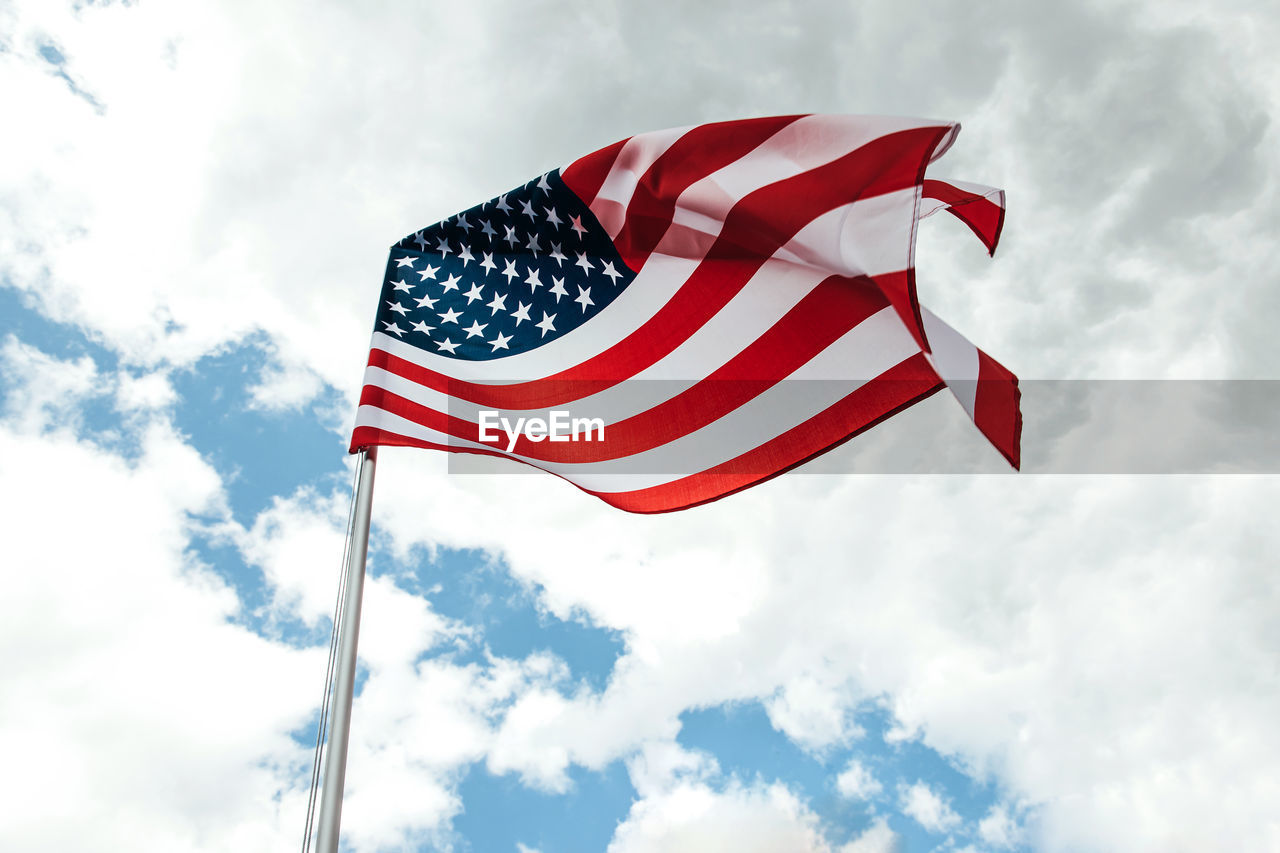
356,307 -> 919,492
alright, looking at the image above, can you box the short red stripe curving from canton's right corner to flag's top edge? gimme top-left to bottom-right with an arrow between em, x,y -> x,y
613,115 -> 803,270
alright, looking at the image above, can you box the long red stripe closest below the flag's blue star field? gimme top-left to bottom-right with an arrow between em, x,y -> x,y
360,127 -> 947,410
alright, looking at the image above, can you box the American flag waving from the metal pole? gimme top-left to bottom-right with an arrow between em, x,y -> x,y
351,115 -> 1021,512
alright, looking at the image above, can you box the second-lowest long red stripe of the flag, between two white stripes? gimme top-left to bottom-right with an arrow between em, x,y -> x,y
360,275 -> 884,462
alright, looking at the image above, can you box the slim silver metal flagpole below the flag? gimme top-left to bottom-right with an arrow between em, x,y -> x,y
316,447 -> 378,853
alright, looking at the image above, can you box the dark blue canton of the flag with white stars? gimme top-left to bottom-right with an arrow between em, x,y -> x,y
374,170 -> 635,361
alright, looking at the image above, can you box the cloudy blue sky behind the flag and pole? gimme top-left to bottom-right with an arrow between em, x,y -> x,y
0,0 -> 1280,853
